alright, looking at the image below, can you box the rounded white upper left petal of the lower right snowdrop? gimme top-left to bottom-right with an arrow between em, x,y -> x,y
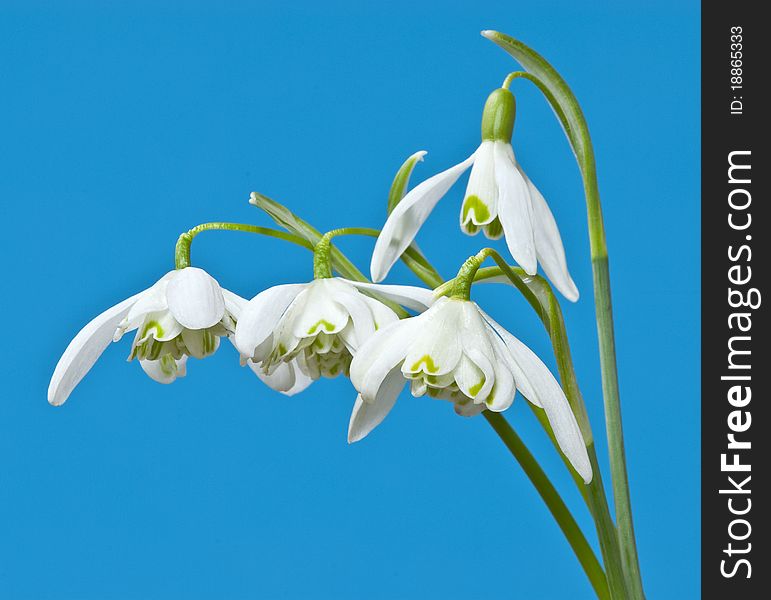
351,317 -> 422,402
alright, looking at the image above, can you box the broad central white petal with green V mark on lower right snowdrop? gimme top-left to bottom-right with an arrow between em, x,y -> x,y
402,298 -> 463,376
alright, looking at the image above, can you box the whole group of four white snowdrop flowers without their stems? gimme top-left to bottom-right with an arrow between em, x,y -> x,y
48,82 -> 592,482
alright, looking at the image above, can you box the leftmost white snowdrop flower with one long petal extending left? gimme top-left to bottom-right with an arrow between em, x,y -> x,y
48,267 -> 246,406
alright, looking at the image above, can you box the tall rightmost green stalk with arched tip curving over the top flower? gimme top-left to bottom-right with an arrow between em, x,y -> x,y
482,31 -> 644,600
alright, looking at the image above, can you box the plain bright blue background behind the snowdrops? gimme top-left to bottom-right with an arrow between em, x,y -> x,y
0,0 -> 700,599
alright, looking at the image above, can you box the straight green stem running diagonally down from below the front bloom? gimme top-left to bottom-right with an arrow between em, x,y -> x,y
482,410 -> 610,600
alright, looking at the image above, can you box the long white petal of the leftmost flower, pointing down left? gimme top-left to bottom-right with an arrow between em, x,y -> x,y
48,292 -> 145,406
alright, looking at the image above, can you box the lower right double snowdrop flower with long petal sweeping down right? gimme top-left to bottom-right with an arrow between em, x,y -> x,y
348,298 -> 592,483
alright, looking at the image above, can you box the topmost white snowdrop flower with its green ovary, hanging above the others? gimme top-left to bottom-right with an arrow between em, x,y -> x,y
370,88 -> 578,301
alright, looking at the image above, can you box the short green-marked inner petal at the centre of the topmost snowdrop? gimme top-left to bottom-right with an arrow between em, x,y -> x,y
460,140 -> 498,235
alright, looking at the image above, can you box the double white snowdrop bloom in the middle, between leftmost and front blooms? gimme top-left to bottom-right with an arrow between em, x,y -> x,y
234,278 -> 434,395
